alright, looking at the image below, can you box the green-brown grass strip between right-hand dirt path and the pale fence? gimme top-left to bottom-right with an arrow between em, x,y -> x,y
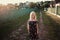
43,13 -> 60,40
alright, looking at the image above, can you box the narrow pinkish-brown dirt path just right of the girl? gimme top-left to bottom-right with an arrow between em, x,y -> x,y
39,12 -> 48,40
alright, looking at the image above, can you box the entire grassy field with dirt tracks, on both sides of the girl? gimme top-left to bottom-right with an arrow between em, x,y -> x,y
0,8 -> 60,40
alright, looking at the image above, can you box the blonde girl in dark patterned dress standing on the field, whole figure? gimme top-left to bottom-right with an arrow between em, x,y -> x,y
27,11 -> 38,40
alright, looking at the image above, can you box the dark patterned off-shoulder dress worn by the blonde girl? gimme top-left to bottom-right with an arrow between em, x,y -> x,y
29,21 -> 38,39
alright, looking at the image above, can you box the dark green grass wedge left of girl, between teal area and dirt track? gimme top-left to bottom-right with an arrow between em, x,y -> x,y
0,14 -> 28,37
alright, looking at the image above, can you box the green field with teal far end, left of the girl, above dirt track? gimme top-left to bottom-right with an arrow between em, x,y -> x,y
0,8 -> 39,40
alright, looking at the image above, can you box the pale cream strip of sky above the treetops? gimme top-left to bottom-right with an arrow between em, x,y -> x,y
0,0 -> 50,4
